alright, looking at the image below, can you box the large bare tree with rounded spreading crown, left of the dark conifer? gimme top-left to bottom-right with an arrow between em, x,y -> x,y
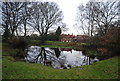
29,2 -> 63,41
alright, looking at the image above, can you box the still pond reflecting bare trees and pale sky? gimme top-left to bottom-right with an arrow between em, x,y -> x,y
25,46 -> 99,69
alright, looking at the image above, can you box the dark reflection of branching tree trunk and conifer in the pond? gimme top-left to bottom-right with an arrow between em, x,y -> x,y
35,47 -> 60,65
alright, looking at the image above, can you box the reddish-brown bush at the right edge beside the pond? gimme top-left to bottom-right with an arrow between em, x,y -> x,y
100,26 -> 120,56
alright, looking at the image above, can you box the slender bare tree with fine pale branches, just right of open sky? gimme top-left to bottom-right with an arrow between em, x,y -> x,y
77,2 -> 94,36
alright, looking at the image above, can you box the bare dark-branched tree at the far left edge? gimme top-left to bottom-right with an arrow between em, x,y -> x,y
2,2 -> 23,37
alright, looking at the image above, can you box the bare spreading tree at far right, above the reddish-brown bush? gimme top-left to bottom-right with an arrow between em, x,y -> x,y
93,1 -> 119,35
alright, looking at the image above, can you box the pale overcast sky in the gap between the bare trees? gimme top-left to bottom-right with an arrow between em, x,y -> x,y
39,0 -> 89,35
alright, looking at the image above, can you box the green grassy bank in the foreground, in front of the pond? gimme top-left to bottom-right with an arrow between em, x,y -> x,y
2,56 -> 120,79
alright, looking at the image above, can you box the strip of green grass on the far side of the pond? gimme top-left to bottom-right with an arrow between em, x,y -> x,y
30,40 -> 86,49
